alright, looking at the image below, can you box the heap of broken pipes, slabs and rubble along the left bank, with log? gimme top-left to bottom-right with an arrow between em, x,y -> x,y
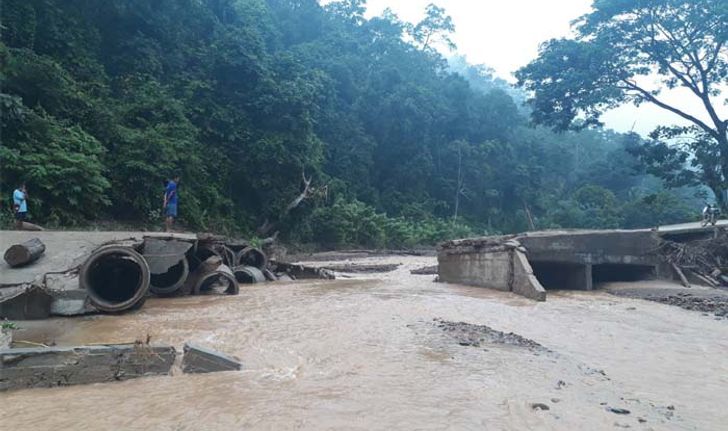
0,235 -> 334,320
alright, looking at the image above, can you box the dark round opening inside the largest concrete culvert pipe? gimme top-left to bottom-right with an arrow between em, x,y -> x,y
87,253 -> 144,303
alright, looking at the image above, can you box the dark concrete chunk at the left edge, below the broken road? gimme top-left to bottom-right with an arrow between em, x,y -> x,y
0,284 -> 52,320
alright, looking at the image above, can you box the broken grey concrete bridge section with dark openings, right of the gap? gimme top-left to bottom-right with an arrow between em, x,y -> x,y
438,223 -> 725,301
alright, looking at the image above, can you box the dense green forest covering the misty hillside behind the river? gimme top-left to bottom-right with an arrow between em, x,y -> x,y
0,0 -> 700,247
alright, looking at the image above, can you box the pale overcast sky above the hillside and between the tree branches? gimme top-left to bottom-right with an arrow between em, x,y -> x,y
367,0 -> 724,135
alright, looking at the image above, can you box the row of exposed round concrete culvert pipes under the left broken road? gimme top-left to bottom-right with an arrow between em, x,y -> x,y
78,238 -> 277,313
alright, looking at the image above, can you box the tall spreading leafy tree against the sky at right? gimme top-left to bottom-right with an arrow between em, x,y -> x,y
517,0 -> 728,206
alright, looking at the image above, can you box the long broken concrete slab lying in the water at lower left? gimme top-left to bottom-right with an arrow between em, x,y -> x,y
0,343 -> 175,391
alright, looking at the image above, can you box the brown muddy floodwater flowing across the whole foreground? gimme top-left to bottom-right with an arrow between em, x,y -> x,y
0,256 -> 728,430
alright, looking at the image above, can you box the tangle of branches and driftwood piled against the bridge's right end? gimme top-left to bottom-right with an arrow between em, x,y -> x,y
659,229 -> 728,287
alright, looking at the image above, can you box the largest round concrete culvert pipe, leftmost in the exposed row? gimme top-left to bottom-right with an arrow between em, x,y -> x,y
78,246 -> 150,313
